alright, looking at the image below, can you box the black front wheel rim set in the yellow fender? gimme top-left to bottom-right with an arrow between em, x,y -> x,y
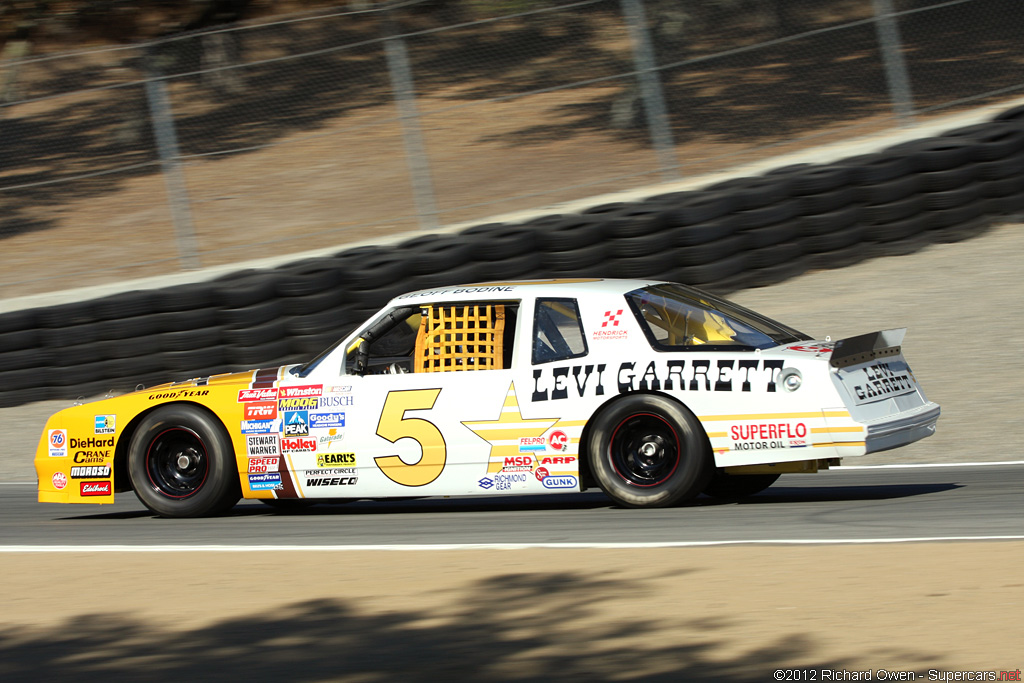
145,427 -> 210,499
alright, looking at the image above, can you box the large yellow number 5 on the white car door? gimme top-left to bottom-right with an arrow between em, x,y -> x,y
374,389 -> 447,486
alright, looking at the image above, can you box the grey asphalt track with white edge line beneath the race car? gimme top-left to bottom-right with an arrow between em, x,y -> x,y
0,463 -> 1024,550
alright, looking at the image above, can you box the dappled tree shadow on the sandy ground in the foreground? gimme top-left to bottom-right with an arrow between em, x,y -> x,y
0,567 -> 884,682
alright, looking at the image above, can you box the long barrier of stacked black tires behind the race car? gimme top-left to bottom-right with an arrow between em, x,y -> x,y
0,108 -> 1024,407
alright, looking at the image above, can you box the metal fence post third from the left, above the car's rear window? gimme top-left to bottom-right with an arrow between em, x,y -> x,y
622,0 -> 679,180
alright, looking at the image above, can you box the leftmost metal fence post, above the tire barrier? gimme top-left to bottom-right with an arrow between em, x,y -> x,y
145,55 -> 200,270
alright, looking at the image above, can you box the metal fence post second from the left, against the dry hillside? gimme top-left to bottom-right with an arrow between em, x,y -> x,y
384,31 -> 438,230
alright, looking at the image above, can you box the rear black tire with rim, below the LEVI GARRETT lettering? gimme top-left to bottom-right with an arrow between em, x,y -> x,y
588,394 -> 712,508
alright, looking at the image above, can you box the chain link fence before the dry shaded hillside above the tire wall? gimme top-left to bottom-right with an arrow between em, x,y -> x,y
0,0 -> 1024,297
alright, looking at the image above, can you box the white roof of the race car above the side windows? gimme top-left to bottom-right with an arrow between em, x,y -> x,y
392,278 -> 665,305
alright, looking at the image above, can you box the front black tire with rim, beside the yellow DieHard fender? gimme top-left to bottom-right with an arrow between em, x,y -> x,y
128,403 -> 242,517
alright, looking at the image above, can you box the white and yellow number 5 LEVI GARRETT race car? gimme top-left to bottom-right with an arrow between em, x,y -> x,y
36,280 -> 939,516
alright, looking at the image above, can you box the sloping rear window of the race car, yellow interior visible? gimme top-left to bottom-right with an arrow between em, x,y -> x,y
626,284 -> 810,351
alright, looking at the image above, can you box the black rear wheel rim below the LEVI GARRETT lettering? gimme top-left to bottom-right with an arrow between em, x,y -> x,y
609,413 -> 680,486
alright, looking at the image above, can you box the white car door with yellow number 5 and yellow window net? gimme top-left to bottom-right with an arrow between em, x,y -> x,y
294,301 -> 519,498
